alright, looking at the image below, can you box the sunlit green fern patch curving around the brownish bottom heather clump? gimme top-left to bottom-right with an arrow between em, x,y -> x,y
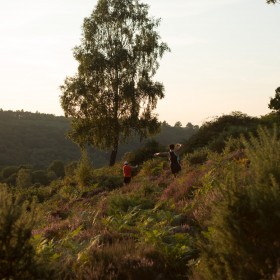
106,202 -> 196,279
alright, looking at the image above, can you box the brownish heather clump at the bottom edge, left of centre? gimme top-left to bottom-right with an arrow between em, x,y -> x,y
76,239 -> 164,280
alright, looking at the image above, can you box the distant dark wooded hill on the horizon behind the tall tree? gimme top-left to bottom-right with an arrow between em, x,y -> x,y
0,109 -> 198,167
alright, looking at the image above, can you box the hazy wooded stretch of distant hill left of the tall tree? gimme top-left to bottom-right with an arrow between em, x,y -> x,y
0,111 -> 80,168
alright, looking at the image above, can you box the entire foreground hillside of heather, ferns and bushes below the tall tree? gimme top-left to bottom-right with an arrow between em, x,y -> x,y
0,113 -> 280,280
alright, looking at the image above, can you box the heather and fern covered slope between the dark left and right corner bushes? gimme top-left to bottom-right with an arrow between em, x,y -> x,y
23,148 -> 242,279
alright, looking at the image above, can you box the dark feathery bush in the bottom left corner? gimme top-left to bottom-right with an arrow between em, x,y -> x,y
0,184 -> 44,279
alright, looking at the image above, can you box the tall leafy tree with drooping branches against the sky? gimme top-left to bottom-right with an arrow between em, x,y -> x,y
61,0 -> 169,165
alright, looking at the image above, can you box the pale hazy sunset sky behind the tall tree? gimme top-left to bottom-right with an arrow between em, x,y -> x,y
0,0 -> 280,125
